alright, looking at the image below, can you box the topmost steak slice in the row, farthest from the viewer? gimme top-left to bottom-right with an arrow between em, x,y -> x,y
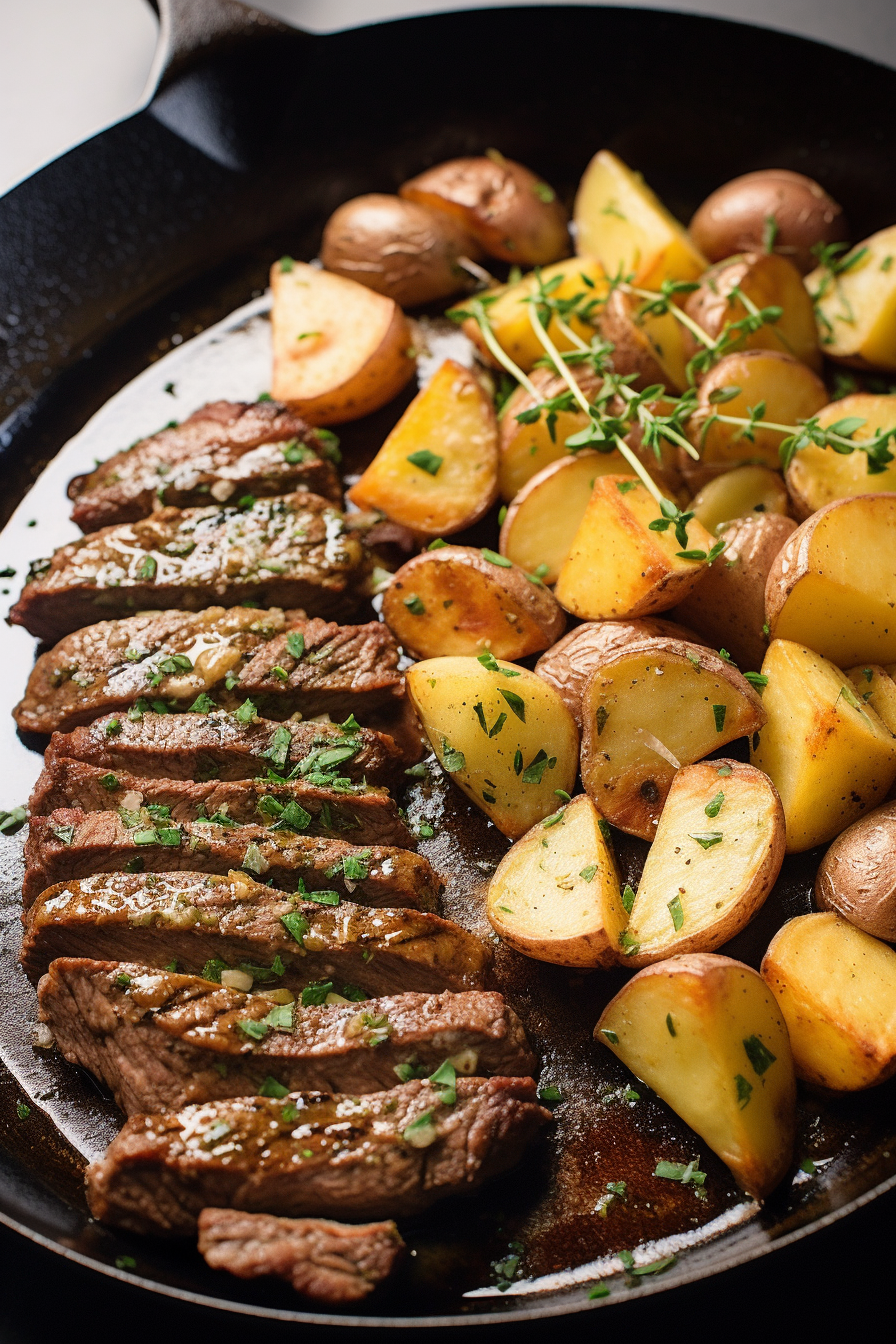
69,402 -> 343,532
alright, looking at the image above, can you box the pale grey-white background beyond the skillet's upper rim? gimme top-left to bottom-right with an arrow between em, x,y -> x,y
0,0 -> 896,194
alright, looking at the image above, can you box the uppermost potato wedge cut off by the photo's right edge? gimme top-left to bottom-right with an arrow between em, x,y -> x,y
806,224 -> 896,370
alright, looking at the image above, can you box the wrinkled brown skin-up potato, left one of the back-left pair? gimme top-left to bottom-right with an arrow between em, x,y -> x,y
321,192 -> 482,308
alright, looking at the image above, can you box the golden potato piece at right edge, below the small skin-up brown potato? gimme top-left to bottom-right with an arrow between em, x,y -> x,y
762,913 -> 896,1091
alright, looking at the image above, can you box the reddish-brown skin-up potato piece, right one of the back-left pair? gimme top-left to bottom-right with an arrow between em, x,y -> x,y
399,149 -> 570,266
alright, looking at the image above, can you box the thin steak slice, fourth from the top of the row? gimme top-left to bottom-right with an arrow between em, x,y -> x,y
44,711 -> 403,785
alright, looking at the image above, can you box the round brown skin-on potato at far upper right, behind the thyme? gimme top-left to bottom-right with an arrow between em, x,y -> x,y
690,168 -> 849,276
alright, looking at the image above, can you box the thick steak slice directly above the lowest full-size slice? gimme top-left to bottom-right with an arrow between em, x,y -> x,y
38,957 -> 536,1116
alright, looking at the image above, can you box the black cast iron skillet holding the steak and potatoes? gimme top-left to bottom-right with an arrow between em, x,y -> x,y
0,0 -> 896,1325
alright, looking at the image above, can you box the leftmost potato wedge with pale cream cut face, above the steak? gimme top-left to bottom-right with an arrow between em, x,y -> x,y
270,257 -> 415,425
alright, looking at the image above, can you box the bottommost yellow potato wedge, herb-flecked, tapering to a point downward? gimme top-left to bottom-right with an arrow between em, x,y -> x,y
594,953 -> 797,1199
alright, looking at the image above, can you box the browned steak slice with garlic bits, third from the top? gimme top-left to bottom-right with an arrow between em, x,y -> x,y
13,606 -> 404,732
